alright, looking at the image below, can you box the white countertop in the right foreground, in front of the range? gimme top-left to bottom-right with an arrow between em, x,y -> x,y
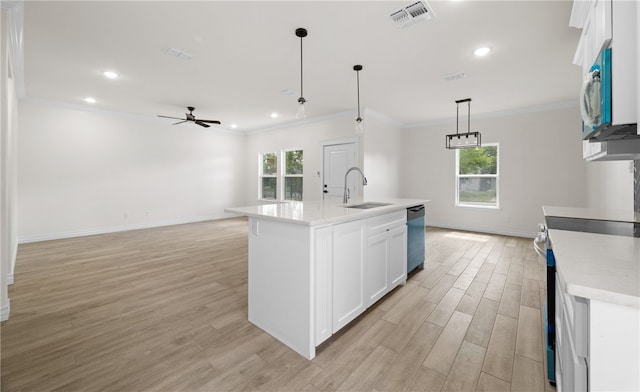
549,229 -> 640,309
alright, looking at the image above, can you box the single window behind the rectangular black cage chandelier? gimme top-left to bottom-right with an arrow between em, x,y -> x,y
456,144 -> 499,208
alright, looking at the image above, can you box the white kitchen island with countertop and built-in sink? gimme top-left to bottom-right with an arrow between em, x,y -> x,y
225,199 -> 428,359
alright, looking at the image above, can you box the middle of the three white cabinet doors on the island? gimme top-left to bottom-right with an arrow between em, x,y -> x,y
365,232 -> 389,307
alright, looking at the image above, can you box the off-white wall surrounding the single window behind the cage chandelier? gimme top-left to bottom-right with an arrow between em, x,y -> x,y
401,107 -> 587,237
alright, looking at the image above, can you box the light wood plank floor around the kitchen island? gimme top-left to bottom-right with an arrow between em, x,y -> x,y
1,219 -> 553,392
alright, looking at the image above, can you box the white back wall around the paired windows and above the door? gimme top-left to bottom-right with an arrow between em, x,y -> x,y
244,114 -> 362,206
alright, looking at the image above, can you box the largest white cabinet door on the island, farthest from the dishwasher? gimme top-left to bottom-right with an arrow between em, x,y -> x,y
333,221 -> 366,333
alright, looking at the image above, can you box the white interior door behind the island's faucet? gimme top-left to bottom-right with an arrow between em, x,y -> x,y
322,143 -> 357,199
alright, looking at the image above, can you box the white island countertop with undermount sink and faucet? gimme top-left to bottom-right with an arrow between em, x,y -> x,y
224,198 -> 429,226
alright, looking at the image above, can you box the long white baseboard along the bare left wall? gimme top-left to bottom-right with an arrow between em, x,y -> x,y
18,213 -> 236,244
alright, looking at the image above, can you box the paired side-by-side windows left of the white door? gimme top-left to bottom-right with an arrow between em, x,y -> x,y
258,150 -> 304,201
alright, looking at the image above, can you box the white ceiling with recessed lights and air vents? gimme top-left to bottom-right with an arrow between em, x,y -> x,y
24,0 -> 581,131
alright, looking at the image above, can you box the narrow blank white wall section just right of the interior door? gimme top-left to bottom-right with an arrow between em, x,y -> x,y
363,111 -> 404,200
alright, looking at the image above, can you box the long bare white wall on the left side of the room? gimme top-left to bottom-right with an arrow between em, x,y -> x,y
18,100 -> 245,242
